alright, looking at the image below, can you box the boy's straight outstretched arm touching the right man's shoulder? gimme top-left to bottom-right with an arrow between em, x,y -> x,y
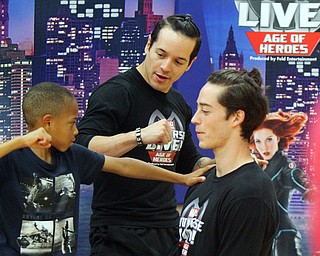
102,156 -> 212,186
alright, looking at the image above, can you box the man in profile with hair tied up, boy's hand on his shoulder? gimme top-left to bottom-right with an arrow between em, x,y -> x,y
169,68 -> 279,256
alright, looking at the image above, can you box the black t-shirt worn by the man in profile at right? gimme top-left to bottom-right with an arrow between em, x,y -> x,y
175,163 -> 279,256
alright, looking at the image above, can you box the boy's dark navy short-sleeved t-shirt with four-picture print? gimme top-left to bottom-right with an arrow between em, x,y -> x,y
0,145 -> 104,256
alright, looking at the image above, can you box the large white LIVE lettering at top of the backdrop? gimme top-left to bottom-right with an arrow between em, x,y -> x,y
235,0 -> 320,32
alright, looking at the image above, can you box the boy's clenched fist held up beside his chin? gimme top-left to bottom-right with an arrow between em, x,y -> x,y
23,127 -> 51,148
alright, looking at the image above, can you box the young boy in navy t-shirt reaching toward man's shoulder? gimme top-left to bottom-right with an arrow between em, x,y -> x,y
0,82 -> 209,256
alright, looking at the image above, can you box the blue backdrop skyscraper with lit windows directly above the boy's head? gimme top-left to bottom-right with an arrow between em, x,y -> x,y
45,17 -> 93,110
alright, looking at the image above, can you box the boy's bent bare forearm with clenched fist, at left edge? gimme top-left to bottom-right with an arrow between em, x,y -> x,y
0,127 -> 51,158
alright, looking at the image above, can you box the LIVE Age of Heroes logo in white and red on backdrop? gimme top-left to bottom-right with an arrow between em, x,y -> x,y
235,0 -> 320,56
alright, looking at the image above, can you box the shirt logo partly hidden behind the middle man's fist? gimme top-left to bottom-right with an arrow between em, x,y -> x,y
146,110 -> 185,166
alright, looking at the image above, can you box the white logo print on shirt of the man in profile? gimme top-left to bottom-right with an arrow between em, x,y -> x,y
179,198 -> 209,256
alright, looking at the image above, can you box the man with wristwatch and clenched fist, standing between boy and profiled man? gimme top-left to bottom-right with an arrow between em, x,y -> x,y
76,15 -> 212,256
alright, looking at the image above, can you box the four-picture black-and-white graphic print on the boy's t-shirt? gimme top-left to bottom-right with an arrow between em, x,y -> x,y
17,173 -> 76,255
